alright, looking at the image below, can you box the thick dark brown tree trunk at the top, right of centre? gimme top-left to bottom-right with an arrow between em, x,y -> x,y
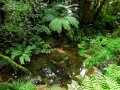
77,0 -> 108,25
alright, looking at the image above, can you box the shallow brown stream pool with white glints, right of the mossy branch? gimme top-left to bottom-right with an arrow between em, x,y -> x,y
27,48 -> 82,85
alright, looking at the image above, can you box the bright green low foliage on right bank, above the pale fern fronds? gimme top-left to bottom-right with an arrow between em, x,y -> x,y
79,36 -> 120,66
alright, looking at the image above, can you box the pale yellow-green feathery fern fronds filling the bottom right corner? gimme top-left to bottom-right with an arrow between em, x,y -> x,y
68,64 -> 120,90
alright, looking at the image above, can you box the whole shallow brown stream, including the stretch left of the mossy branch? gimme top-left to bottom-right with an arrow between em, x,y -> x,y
0,47 -> 92,89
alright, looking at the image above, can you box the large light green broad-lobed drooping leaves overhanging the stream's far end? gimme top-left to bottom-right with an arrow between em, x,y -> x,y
49,17 -> 78,34
